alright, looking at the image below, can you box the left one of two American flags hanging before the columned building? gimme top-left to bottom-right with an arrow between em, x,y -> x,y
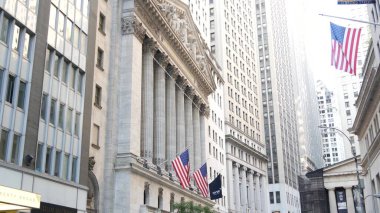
172,149 -> 190,188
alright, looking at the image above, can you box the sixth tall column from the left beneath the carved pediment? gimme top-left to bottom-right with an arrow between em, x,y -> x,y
193,96 -> 203,170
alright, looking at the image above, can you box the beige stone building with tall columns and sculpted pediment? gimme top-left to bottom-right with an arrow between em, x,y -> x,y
93,0 -> 219,212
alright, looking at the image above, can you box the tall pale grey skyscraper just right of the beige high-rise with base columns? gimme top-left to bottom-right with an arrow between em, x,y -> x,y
255,0 -> 301,212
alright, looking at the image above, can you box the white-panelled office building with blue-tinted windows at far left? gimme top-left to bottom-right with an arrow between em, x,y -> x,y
0,0 -> 90,212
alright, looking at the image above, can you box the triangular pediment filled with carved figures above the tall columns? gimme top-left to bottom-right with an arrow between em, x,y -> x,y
157,0 -> 216,88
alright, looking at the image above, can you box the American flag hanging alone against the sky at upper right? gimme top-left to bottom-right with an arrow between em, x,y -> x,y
330,22 -> 361,75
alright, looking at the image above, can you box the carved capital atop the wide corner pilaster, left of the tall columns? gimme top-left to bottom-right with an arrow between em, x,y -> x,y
121,16 -> 146,42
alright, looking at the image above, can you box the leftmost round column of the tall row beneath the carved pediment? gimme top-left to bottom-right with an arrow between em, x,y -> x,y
141,39 -> 157,162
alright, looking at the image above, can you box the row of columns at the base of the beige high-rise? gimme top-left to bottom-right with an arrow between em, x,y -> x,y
232,162 -> 267,212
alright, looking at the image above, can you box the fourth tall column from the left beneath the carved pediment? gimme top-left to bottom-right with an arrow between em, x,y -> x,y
176,77 -> 186,153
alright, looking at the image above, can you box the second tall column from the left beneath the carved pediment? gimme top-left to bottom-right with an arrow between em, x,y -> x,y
153,53 -> 169,165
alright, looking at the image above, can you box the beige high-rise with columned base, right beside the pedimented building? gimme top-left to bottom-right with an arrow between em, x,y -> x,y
210,0 -> 268,212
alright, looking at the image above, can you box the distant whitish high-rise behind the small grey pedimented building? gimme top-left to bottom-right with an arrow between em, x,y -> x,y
317,80 -> 347,166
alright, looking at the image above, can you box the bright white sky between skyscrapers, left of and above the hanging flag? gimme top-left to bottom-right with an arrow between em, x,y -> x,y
303,0 -> 368,88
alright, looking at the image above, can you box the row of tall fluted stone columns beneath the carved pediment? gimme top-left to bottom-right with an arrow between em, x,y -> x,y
141,39 -> 208,171
